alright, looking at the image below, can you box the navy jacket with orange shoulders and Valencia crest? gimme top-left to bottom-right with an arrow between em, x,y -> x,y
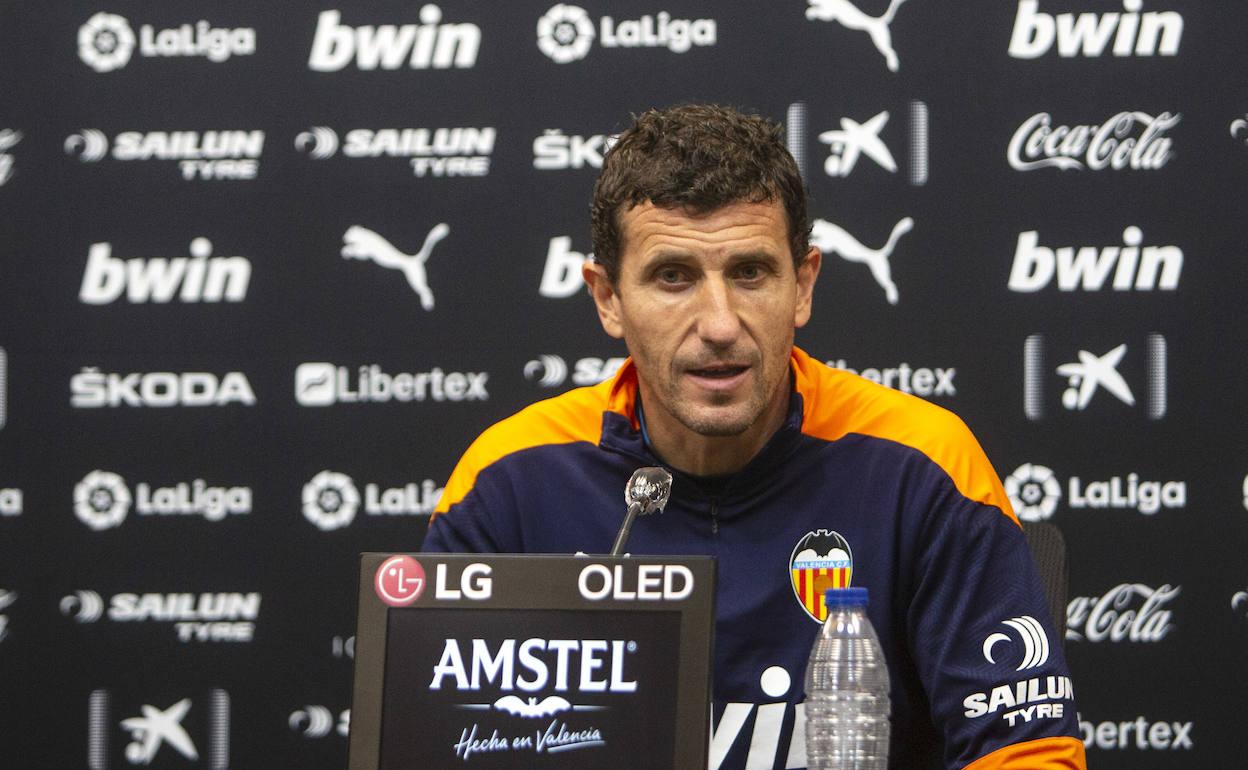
424,348 -> 1086,770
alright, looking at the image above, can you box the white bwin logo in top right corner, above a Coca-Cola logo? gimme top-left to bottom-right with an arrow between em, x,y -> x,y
1010,0 -> 1183,59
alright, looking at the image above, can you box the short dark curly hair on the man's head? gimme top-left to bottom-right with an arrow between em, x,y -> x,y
590,105 -> 810,283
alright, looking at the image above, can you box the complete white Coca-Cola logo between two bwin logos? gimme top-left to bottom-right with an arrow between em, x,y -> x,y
1007,110 -> 1182,171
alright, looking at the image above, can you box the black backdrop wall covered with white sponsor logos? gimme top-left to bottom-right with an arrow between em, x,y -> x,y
0,0 -> 1248,769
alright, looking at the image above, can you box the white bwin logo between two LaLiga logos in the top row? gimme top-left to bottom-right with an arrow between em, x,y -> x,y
308,2 -> 480,72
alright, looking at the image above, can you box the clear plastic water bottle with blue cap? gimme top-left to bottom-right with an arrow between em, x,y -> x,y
806,588 -> 890,770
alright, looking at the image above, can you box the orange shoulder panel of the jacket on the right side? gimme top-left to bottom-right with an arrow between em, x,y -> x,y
792,348 -> 1018,524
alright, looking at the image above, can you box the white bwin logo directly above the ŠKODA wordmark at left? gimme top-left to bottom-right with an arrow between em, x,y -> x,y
79,237 -> 251,305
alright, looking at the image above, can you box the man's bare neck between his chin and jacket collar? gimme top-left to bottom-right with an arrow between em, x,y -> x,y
638,391 -> 789,475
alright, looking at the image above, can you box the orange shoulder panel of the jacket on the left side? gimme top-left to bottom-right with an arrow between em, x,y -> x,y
431,361 -> 636,520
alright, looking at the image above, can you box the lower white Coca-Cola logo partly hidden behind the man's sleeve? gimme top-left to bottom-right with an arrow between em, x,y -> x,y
1066,583 -> 1182,643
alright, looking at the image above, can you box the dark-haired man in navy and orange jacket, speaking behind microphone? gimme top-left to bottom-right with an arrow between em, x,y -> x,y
424,106 -> 1085,770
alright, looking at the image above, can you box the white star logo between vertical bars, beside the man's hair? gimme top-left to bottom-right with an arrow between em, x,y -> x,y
785,101 -> 929,187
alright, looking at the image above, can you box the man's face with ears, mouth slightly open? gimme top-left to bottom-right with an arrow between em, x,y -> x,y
585,201 -> 820,437
